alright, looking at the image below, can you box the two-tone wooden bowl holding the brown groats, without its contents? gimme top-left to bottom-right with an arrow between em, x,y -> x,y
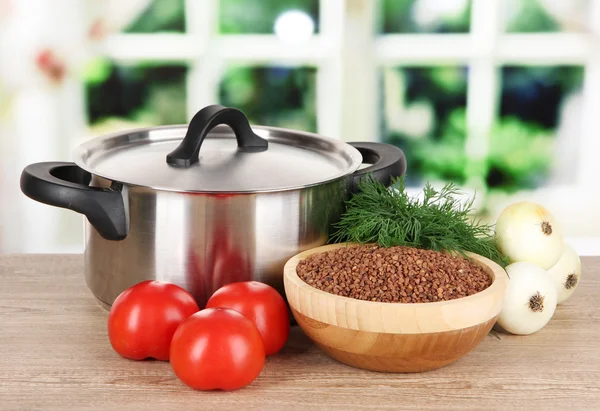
283,244 -> 508,372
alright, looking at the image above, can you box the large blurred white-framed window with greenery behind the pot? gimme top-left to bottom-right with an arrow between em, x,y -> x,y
4,0 -> 600,254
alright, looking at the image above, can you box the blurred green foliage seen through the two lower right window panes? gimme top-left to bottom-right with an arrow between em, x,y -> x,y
384,67 -> 583,192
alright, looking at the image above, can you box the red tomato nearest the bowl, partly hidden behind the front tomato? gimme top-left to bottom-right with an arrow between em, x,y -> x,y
206,281 -> 290,355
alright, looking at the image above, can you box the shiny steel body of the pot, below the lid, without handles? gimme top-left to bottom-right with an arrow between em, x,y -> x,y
84,175 -> 351,307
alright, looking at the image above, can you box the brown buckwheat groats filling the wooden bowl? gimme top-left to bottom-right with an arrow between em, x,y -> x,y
296,245 -> 492,303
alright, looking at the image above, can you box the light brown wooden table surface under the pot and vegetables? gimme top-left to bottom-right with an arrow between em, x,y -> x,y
0,255 -> 600,411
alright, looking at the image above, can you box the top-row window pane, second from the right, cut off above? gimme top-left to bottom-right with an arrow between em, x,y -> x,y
378,0 -> 471,33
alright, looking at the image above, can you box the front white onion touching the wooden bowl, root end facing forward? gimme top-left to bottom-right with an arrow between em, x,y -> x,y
497,262 -> 556,335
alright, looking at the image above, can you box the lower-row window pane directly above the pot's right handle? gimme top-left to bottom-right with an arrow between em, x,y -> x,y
382,66 -> 467,185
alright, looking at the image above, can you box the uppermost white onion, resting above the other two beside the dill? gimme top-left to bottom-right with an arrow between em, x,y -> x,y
494,201 -> 563,270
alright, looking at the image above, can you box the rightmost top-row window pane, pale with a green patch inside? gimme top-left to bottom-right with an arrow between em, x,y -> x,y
503,0 -> 589,33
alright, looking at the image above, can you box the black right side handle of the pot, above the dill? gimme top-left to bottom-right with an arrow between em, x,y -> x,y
349,142 -> 406,192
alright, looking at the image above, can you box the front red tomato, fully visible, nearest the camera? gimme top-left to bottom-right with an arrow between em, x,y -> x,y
171,308 -> 265,390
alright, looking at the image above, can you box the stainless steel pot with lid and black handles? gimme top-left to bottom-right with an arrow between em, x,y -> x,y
21,106 -> 406,307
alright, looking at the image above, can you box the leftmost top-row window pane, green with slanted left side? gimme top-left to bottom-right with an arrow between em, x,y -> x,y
124,0 -> 185,33
